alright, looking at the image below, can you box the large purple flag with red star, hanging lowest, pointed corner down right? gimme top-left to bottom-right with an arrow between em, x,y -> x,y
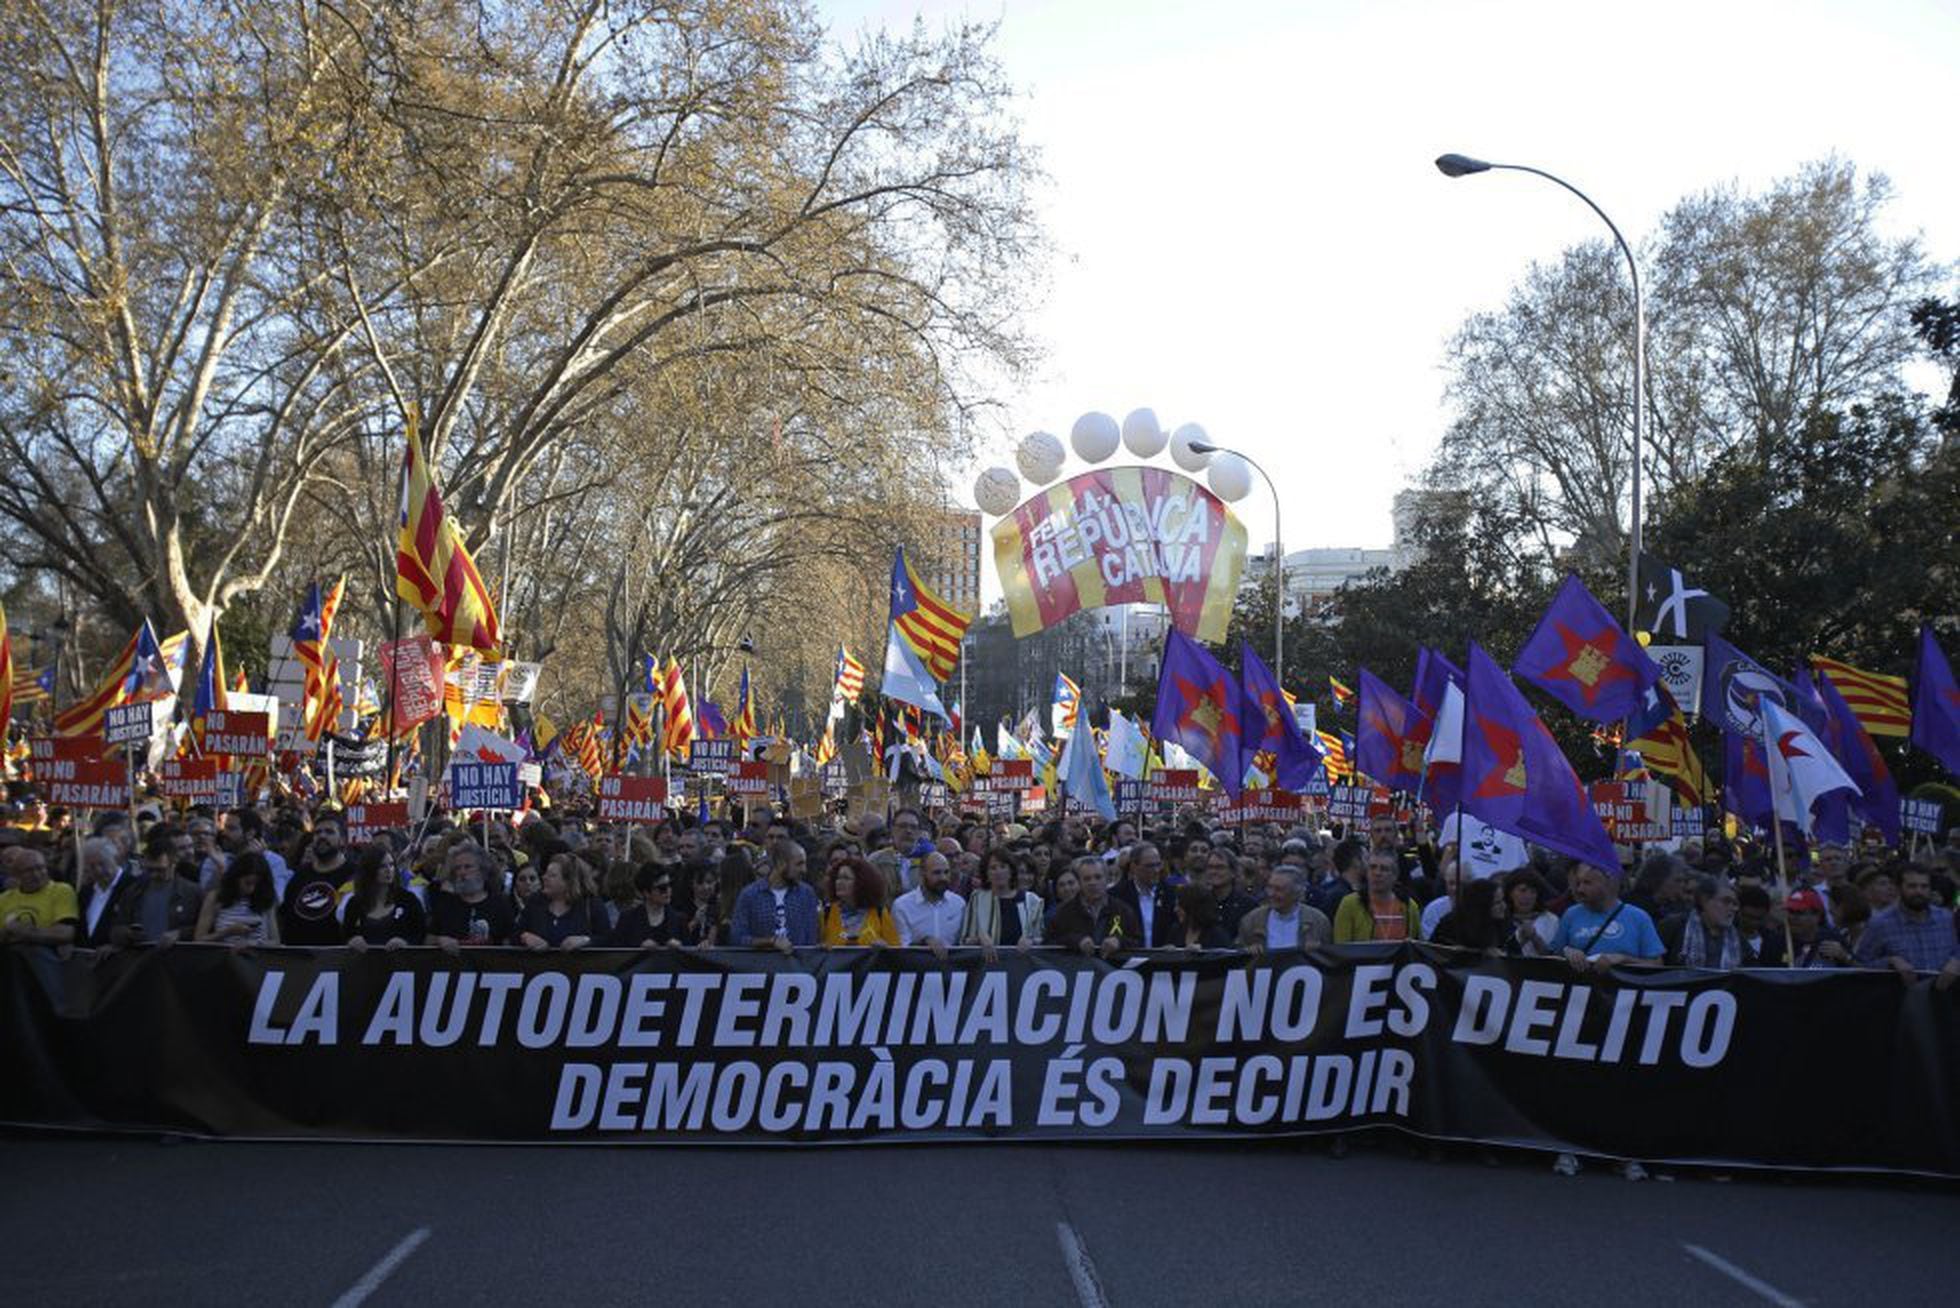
1458,643 -> 1619,875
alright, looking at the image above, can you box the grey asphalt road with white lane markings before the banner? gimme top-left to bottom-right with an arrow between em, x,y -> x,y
0,1135 -> 1960,1308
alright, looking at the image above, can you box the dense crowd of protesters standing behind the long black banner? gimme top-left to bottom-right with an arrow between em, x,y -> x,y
0,784 -> 1960,988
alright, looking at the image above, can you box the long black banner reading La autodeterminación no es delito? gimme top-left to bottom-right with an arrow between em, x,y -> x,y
0,943 -> 1960,1177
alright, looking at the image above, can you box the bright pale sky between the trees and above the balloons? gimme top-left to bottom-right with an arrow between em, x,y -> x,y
819,0 -> 1960,568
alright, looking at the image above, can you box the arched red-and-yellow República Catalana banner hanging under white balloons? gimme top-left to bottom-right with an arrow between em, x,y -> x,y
994,467 -> 1245,641
